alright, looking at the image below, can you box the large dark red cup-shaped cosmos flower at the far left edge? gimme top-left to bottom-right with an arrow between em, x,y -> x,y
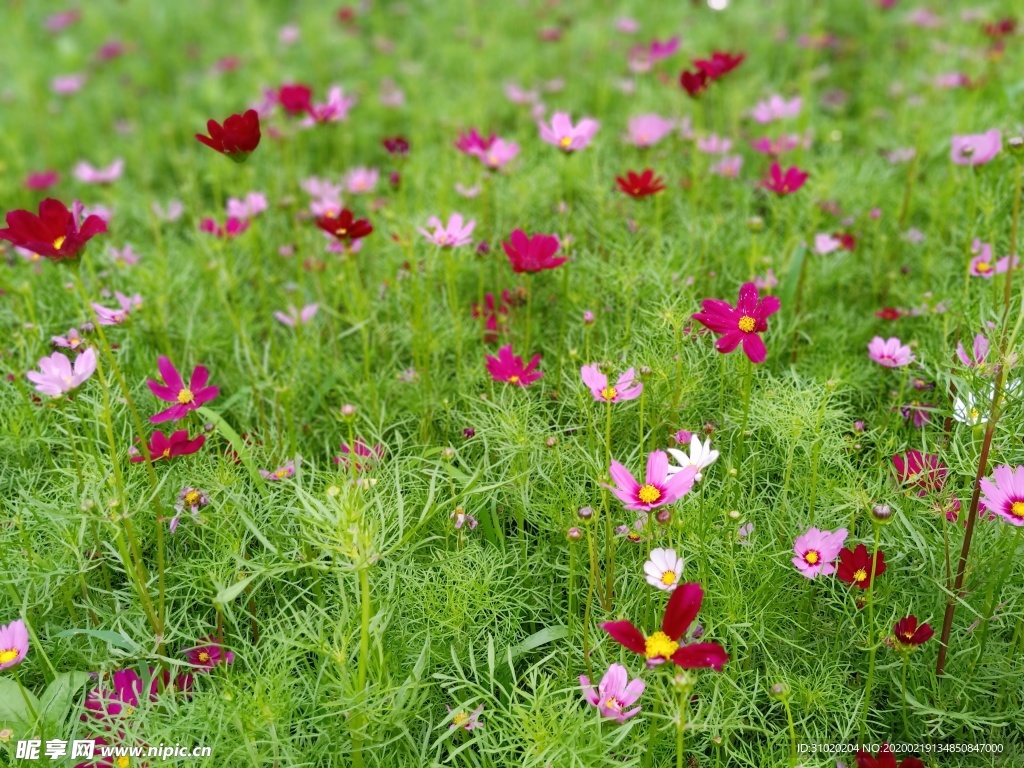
0,198 -> 106,261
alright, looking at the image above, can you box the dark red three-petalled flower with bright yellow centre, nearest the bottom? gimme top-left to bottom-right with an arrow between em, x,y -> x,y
601,582 -> 729,672
